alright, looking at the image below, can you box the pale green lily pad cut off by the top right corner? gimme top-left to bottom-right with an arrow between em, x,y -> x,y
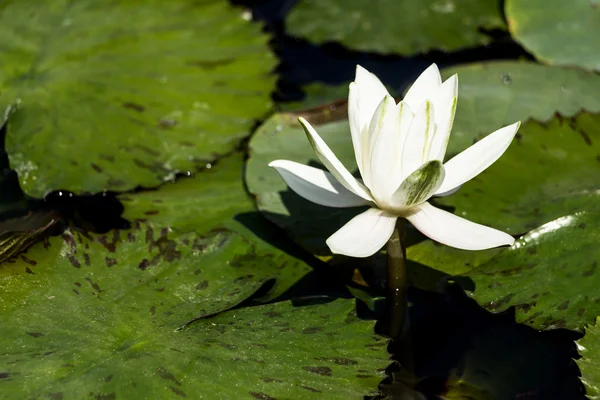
505,0 -> 600,71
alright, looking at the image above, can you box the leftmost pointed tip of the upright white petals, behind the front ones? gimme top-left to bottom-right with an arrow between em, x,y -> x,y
348,65 -> 389,128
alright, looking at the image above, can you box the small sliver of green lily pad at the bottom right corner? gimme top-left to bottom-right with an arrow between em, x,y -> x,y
575,318 -> 600,400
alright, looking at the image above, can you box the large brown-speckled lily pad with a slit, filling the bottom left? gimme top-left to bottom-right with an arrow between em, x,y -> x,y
0,154 -> 389,399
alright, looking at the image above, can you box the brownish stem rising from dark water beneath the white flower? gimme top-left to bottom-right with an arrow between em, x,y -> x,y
386,218 -> 408,338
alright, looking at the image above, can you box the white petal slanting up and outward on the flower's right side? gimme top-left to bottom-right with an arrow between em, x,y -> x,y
436,122 -> 521,194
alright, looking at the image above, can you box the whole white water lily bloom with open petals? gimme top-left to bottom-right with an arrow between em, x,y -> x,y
269,64 -> 520,257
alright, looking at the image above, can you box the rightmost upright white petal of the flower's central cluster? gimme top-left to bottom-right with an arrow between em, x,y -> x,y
427,74 -> 458,162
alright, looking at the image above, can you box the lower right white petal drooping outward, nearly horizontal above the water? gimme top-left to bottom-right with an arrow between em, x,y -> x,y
407,203 -> 515,250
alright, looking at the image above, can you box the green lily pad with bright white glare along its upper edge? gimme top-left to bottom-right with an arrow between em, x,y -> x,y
457,212 -> 600,330
